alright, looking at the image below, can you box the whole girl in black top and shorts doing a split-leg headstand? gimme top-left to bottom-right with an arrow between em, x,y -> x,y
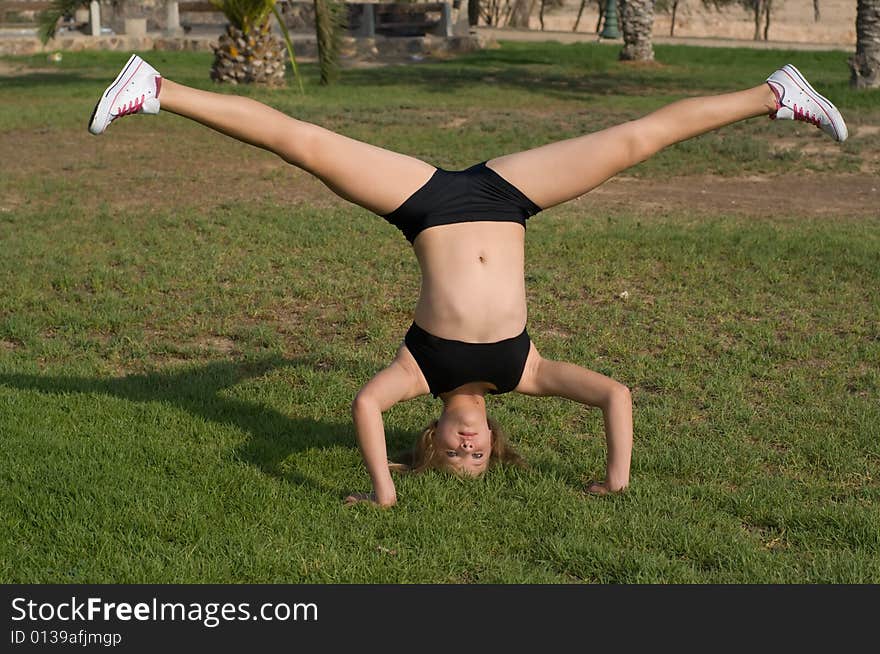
89,55 -> 847,506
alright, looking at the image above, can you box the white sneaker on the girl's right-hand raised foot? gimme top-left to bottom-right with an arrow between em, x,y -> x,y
767,64 -> 849,142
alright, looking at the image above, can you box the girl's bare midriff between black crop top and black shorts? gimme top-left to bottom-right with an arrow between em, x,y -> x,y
413,222 -> 527,343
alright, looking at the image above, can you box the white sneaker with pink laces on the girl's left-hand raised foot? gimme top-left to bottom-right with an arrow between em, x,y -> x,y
89,55 -> 162,134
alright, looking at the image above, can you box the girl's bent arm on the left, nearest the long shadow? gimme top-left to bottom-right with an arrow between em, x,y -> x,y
345,346 -> 428,506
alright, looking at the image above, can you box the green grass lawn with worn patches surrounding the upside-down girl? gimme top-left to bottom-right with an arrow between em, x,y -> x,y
0,44 -> 880,583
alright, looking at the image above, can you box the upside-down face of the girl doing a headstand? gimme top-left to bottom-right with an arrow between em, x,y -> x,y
434,407 -> 492,477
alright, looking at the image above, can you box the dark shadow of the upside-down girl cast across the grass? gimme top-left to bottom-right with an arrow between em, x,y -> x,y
0,357 -> 412,499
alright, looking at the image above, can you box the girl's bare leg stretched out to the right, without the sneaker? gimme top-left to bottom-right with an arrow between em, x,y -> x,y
487,84 -> 778,209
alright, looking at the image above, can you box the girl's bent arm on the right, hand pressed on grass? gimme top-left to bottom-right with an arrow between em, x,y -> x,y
516,345 -> 633,495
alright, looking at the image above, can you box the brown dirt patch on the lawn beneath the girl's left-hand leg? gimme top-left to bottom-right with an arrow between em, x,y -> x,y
0,127 -> 342,217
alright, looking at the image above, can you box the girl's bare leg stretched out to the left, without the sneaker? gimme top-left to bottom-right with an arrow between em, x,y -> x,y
159,79 -> 436,215
